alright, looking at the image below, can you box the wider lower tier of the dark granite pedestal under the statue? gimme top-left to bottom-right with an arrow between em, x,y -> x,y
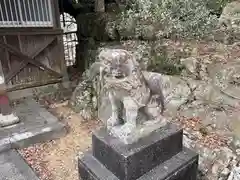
78,148 -> 198,180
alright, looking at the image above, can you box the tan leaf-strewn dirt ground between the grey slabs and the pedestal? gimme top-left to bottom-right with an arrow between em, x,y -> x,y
20,102 -> 100,180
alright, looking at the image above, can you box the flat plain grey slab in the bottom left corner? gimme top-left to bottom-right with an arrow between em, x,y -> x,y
0,150 -> 39,180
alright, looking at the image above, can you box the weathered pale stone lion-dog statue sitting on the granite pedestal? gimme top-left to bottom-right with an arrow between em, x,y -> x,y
89,49 -> 166,144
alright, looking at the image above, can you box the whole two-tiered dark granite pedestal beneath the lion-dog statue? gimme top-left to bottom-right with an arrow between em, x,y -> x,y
78,124 -> 198,180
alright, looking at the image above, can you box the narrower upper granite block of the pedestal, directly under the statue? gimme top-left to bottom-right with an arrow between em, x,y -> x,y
92,124 -> 183,180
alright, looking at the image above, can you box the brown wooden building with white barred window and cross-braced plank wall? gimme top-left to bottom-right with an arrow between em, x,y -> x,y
0,0 -> 67,95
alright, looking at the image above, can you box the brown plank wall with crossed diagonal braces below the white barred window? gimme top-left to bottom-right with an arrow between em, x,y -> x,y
0,31 -> 65,91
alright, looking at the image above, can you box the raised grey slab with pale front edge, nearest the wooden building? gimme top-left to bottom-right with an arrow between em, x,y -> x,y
0,98 -> 66,152
